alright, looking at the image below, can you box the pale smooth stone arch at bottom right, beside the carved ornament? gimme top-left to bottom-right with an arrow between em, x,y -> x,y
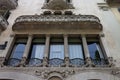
66,72 -> 120,80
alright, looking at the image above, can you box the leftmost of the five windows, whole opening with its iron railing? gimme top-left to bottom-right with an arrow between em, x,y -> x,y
8,39 -> 27,66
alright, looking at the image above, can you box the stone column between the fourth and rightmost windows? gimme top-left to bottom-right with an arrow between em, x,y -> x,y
82,35 -> 92,66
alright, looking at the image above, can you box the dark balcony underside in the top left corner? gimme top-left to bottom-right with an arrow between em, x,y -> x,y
0,0 -> 18,10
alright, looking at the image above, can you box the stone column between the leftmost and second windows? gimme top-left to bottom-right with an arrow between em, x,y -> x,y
20,35 -> 33,66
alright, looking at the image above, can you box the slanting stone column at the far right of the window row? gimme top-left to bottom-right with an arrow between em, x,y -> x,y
99,34 -> 114,66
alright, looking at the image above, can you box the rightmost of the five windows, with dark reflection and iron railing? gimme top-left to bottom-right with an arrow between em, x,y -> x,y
87,38 -> 107,65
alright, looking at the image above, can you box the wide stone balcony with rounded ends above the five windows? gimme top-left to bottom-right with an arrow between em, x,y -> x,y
12,14 -> 102,31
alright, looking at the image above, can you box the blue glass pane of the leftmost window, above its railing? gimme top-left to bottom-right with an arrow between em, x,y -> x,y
10,44 -> 25,59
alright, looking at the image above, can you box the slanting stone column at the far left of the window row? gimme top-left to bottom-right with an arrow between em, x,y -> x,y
0,34 -> 15,66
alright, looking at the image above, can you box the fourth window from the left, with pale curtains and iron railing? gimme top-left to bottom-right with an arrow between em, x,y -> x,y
68,38 -> 84,66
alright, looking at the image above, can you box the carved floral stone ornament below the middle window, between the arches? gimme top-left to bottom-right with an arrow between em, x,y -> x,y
35,70 -> 75,79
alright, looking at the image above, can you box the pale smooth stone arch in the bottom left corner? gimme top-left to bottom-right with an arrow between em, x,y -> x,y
0,72 -> 43,80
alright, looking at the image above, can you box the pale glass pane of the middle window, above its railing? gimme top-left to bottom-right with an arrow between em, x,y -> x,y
49,44 -> 64,59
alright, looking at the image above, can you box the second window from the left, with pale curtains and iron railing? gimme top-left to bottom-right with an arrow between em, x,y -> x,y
29,38 -> 45,66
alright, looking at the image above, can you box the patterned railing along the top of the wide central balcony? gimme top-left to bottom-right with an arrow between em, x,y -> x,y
15,15 -> 100,23
